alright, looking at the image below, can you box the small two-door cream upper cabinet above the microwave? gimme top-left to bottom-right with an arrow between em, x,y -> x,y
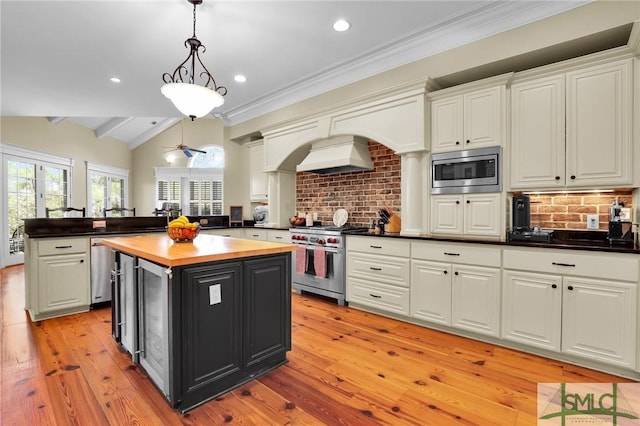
431,85 -> 506,152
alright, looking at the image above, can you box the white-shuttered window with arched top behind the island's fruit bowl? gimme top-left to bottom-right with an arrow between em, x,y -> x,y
156,146 -> 224,216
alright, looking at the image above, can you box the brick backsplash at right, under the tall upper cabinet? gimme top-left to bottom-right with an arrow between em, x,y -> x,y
529,190 -> 633,230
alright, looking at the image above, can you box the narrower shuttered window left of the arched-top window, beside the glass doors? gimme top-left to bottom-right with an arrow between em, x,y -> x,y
87,162 -> 129,217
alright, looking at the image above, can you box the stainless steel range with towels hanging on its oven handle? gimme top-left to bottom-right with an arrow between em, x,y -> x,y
289,226 -> 352,306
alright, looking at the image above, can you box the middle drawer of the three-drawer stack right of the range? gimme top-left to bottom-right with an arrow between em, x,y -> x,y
347,253 -> 411,287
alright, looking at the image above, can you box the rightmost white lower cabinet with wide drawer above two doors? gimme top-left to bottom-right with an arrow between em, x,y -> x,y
502,249 -> 639,369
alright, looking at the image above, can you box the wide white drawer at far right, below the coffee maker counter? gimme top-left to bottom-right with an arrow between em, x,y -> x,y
503,249 -> 639,282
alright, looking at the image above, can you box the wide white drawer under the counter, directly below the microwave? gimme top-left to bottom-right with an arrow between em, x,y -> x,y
411,242 -> 500,268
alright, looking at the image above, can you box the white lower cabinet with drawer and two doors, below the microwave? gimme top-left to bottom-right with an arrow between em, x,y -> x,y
411,242 -> 501,337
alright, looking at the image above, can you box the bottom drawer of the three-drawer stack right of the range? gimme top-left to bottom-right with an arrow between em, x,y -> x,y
347,277 -> 409,315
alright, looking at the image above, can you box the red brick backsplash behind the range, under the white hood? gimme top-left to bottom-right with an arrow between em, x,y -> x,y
290,141 -> 400,226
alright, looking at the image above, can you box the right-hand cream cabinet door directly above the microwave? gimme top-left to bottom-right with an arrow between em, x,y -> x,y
462,86 -> 505,149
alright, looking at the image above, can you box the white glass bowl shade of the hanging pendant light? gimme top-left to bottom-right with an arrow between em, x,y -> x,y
160,83 -> 224,118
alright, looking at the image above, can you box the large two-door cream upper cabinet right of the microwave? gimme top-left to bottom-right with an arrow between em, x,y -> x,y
510,59 -> 633,190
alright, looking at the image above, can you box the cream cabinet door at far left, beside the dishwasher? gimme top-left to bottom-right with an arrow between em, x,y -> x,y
38,253 -> 91,312
